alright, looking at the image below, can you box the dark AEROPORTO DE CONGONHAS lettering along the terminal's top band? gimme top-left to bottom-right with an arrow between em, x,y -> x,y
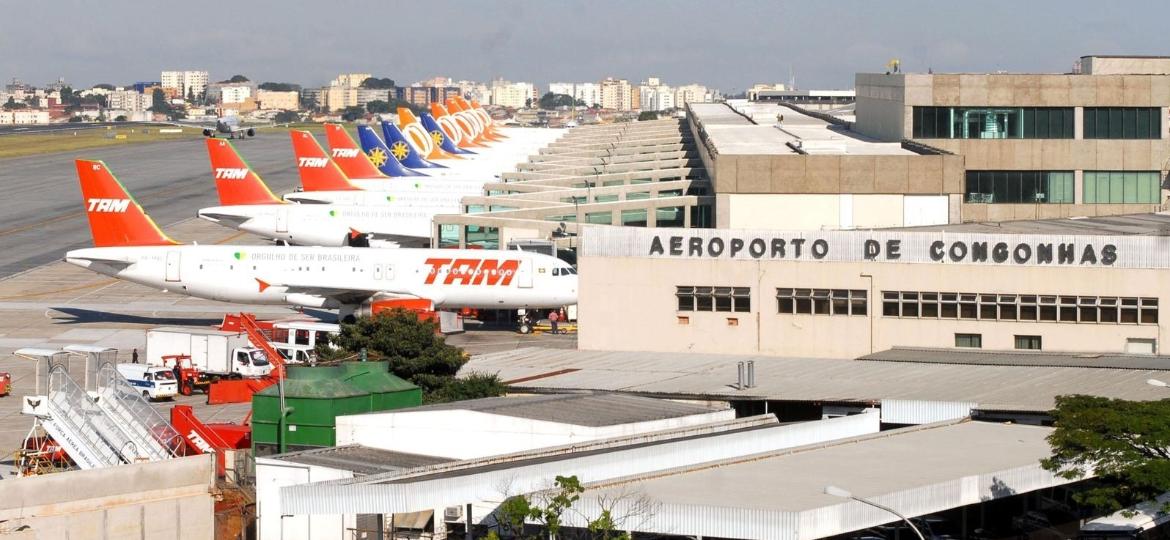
648,235 -> 1117,266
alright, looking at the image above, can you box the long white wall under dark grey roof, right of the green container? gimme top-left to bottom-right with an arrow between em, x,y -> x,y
337,409 -> 735,459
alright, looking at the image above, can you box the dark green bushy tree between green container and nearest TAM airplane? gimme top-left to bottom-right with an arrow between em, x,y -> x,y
317,309 -> 505,403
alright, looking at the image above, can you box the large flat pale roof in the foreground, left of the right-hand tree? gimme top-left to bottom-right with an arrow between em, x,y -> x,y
586,422 -> 1052,512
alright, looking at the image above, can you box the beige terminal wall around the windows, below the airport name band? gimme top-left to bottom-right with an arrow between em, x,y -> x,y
578,257 -> 1170,358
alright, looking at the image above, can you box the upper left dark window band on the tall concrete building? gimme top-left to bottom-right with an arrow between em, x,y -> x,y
911,106 -> 1075,139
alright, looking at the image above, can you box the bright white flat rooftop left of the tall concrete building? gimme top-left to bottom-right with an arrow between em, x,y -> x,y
689,99 -> 915,155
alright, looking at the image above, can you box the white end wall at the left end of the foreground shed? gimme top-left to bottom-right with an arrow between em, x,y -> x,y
256,458 -> 357,540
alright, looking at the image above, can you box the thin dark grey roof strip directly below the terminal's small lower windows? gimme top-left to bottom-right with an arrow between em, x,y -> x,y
858,347 -> 1170,371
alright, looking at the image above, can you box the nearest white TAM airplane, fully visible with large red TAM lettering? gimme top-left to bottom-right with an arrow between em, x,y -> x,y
64,159 -> 577,321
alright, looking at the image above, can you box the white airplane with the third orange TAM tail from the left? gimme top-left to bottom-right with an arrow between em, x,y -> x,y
284,130 -> 486,205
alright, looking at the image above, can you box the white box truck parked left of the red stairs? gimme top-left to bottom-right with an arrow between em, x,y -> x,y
146,327 -> 273,381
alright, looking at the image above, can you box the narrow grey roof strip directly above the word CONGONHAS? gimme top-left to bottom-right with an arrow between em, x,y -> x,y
889,214 -> 1170,236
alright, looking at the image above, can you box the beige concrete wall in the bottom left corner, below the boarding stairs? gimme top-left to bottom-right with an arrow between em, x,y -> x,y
0,456 -> 215,540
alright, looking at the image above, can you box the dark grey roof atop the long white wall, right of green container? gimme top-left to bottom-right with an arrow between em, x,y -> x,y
383,394 -> 728,427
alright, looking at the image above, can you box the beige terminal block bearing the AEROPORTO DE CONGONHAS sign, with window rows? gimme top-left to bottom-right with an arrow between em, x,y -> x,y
579,214 -> 1170,358
